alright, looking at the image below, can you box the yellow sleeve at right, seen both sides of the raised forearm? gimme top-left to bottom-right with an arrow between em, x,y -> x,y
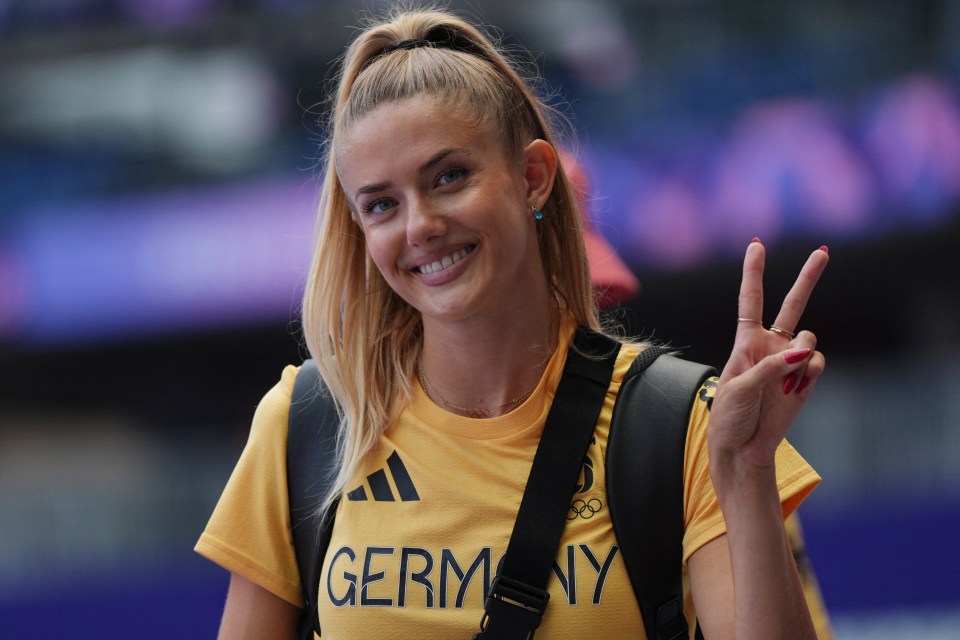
683,378 -> 820,563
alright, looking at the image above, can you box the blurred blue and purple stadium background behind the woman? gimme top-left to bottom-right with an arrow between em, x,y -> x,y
0,0 -> 960,640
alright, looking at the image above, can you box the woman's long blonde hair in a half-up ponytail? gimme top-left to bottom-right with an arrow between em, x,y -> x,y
303,5 -> 600,510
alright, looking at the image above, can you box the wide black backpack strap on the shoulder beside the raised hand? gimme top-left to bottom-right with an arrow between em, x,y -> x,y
606,347 -> 717,640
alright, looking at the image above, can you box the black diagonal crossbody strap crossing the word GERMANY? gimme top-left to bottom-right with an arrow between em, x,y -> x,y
473,328 -> 632,640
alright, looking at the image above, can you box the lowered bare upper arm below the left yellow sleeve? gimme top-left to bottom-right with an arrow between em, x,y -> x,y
217,573 -> 300,640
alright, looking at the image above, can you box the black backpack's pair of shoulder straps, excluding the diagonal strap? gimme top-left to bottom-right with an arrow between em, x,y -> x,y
287,336 -> 717,640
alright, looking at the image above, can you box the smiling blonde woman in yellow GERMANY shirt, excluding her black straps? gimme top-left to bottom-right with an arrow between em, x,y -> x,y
197,6 -> 827,640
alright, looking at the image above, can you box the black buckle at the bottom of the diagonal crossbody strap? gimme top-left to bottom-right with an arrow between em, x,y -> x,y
473,575 -> 550,640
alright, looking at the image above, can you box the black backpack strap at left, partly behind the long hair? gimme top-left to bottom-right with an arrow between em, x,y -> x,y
287,360 -> 340,640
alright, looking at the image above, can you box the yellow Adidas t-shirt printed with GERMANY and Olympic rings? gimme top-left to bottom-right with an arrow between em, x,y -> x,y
196,333 -> 819,640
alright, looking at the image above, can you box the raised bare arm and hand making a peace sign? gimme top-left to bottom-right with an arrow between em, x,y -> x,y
689,242 -> 828,640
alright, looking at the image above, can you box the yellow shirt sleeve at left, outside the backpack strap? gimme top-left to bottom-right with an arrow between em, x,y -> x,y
194,366 -> 302,606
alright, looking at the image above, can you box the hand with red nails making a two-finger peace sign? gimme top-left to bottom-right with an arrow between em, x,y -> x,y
708,239 -> 829,480
